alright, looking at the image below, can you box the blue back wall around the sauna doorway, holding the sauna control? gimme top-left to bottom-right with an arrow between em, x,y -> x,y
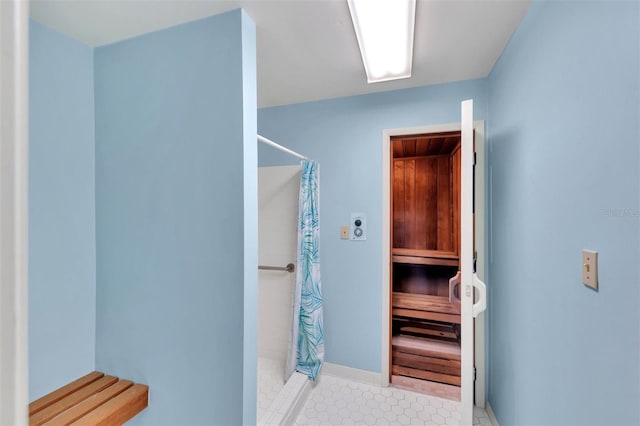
258,79 -> 487,372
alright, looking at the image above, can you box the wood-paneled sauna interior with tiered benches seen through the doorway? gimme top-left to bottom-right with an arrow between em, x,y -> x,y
390,131 -> 461,398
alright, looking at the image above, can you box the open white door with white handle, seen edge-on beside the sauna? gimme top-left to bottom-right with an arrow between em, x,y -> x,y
460,100 -> 486,425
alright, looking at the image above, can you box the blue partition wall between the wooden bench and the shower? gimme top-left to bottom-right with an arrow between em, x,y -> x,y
94,10 -> 257,425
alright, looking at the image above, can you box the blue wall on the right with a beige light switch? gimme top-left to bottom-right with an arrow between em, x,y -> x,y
489,1 -> 640,425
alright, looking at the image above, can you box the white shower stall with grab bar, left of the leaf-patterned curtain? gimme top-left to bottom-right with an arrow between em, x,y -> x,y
257,166 -> 310,425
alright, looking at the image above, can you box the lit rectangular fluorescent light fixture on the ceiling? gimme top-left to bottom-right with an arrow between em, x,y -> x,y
347,0 -> 416,83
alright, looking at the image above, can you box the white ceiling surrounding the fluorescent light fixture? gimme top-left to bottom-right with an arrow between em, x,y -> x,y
30,0 -> 531,107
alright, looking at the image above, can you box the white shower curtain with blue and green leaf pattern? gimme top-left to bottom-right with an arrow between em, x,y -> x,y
286,161 -> 324,380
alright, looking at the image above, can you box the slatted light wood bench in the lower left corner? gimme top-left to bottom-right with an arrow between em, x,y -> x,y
29,371 -> 149,426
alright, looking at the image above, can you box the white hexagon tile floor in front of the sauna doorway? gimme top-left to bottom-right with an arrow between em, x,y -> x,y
295,375 -> 492,426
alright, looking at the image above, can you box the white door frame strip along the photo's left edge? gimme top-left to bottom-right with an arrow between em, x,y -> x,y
0,0 -> 29,425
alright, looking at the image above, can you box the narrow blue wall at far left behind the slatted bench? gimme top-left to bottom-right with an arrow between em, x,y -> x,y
29,20 -> 96,400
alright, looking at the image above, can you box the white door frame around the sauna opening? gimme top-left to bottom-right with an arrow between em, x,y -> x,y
380,120 -> 486,407
